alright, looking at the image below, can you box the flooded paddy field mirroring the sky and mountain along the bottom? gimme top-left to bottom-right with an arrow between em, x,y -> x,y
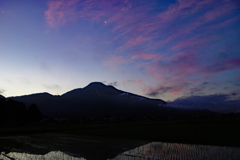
0,134 -> 240,160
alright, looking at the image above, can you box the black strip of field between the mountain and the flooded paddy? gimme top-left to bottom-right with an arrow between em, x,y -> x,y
0,117 -> 240,147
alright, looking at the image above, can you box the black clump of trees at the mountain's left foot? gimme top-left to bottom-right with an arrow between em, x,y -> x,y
0,98 -> 43,126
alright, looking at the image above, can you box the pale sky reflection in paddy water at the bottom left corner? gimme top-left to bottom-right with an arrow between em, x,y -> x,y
0,151 -> 85,160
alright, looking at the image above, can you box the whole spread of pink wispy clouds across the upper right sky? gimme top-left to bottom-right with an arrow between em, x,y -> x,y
45,0 -> 240,99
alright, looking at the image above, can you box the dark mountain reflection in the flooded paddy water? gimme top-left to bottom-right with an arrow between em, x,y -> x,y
0,133 -> 149,160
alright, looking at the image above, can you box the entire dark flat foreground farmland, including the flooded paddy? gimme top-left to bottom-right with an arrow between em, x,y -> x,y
0,122 -> 240,160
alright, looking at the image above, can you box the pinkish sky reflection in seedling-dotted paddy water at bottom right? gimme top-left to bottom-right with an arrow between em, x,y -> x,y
109,142 -> 240,160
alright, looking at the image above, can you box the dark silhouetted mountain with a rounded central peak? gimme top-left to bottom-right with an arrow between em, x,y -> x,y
9,82 -> 212,118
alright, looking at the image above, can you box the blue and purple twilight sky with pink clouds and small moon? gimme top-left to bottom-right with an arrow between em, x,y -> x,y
0,0 -> 240,104
